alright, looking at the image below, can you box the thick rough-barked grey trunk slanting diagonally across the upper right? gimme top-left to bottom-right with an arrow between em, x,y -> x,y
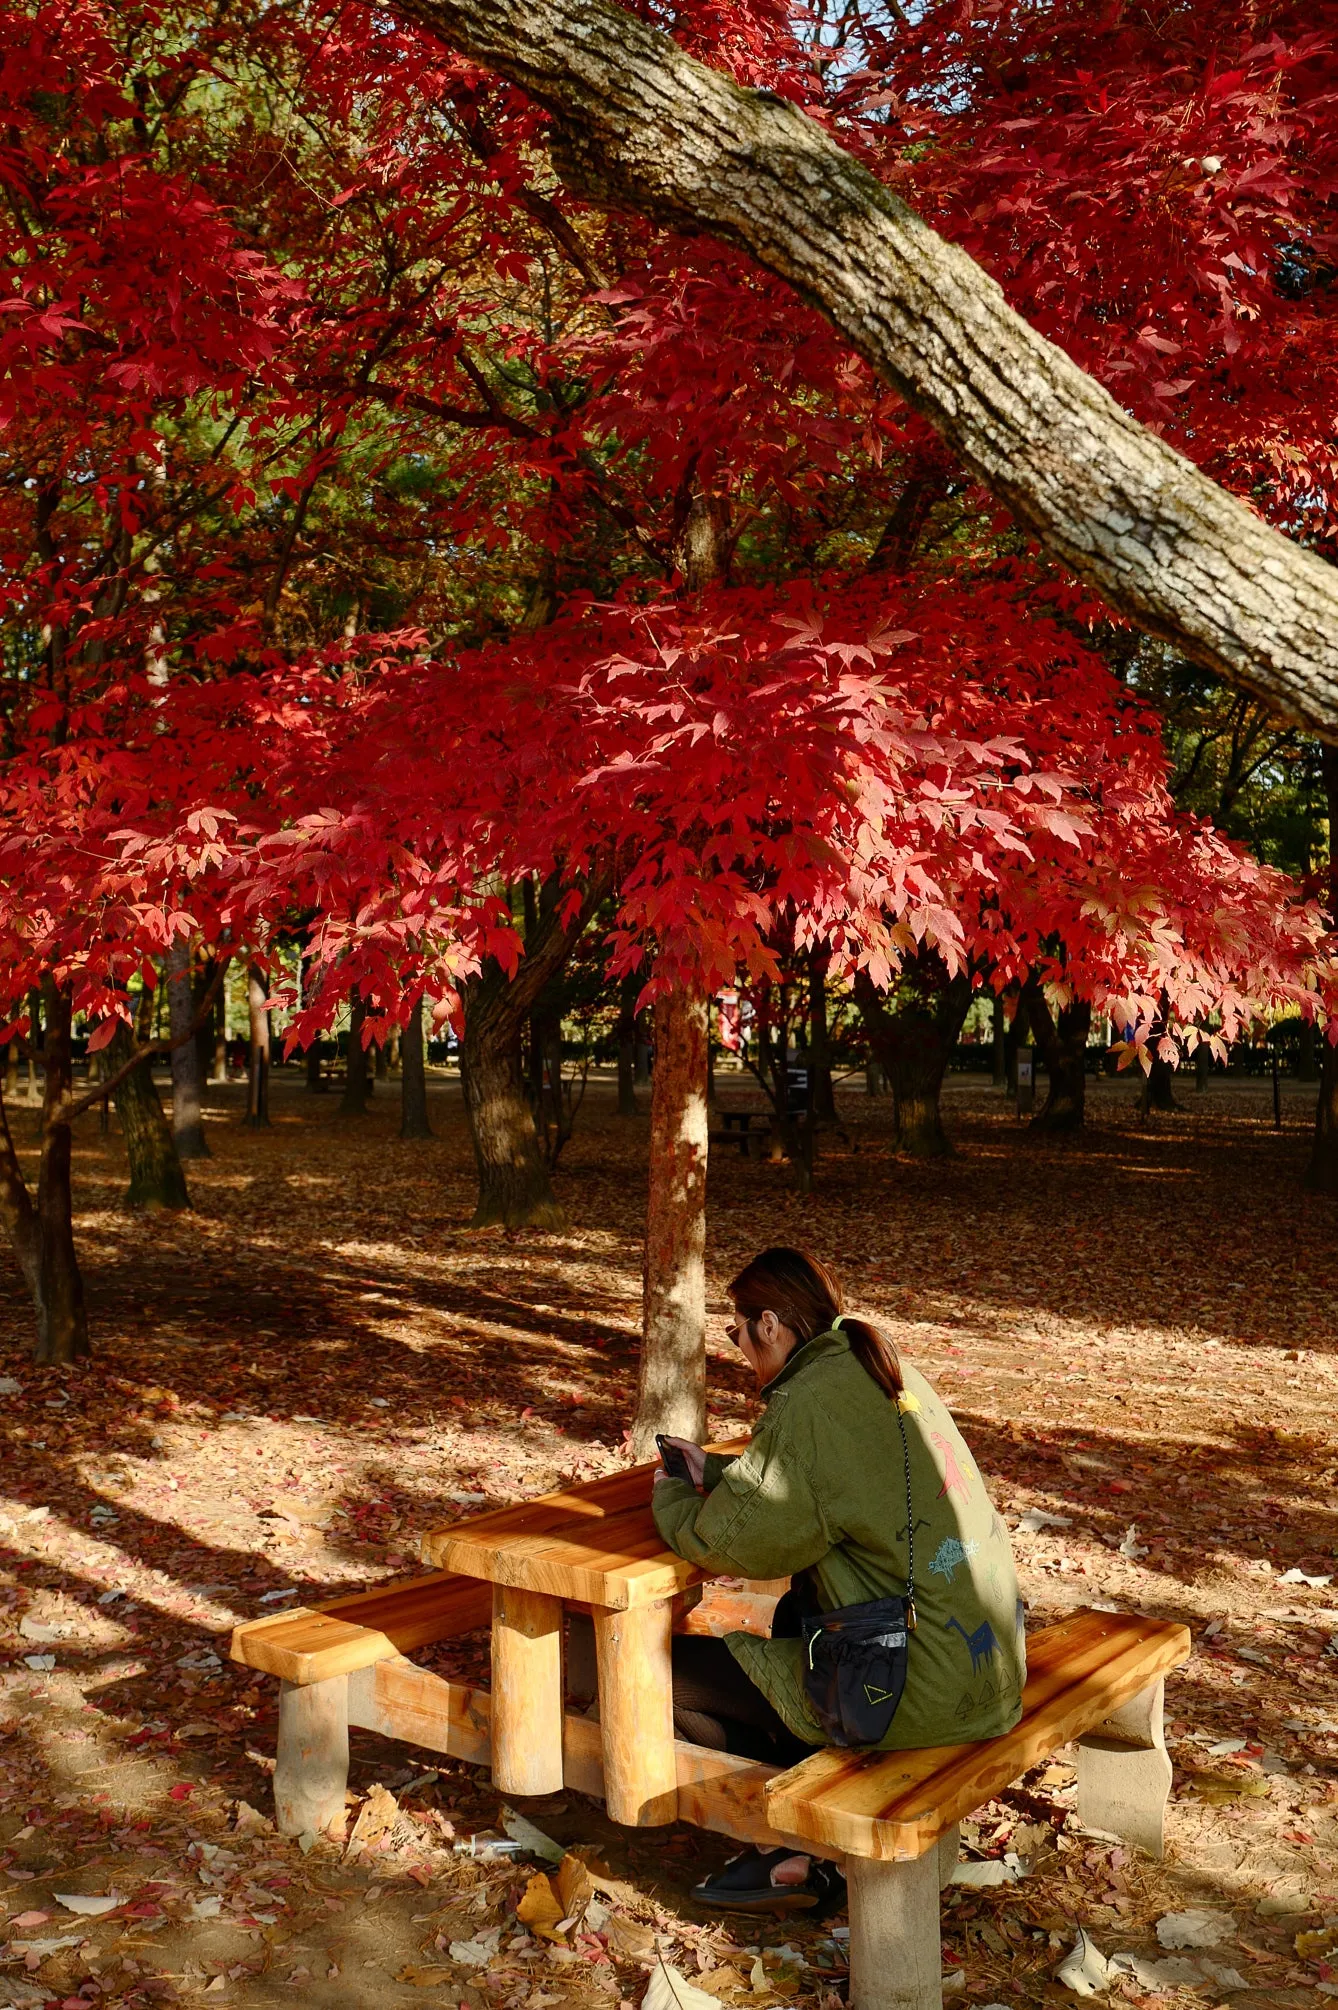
392,0 -> 1338,728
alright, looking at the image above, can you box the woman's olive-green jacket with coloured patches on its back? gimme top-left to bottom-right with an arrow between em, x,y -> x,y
653,1329 -> 1027,1751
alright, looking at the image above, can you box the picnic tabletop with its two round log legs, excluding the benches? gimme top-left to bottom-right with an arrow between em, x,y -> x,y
422,1465 -> 723,1827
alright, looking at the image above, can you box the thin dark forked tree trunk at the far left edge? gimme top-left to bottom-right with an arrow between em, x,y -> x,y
0,977 -> 88,1363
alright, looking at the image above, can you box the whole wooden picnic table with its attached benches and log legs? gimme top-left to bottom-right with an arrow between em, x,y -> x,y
231,1467 -> 1189,2010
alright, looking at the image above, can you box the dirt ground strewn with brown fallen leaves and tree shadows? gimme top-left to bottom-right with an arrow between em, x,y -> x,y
0,1071 -> 1338,2010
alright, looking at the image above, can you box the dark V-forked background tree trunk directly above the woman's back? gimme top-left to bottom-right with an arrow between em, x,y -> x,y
854,951 -> 970,1158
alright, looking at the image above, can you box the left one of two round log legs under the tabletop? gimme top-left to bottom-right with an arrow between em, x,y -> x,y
492,1584 -> 563,1793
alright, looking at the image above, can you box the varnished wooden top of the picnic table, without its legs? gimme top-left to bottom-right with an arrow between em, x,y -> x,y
422,1445 -> 739,1612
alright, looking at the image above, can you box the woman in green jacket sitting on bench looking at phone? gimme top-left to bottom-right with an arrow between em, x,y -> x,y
653,1248 -> 1027,1912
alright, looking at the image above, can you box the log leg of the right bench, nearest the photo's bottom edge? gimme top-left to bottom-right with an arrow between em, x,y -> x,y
846,1847 -> 942,2010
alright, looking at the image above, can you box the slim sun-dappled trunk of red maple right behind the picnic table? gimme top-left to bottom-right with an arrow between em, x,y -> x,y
631,991 -> 709,1459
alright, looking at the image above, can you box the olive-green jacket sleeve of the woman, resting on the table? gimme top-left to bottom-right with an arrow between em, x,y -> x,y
653,1403 -> 840,1578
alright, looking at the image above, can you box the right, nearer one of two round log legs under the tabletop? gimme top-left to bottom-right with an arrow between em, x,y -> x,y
595,1598 -> 679,1829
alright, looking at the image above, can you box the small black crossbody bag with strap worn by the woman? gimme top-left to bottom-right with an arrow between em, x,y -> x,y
771,1399 -> 916,1745
